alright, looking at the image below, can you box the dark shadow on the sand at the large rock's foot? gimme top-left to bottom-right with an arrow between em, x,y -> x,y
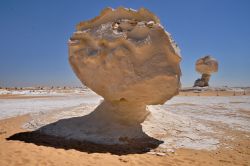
7,131 -> 162,155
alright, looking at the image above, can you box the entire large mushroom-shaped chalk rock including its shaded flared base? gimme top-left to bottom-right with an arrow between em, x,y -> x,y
36,8 -> 181,147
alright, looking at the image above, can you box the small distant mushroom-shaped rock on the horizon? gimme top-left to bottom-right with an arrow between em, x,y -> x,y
194,56 -> 218,87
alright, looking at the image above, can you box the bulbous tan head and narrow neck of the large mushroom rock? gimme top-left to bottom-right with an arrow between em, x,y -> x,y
68,8 -> 181,123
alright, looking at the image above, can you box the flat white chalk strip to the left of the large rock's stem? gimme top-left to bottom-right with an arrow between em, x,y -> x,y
0,91 -> 102,119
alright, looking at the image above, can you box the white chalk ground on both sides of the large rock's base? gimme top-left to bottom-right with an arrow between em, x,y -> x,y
0,89 -> 250,152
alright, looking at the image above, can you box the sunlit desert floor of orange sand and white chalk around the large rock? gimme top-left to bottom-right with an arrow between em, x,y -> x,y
0,89 -> 250,166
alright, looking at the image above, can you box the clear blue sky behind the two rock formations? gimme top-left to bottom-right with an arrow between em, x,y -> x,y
0,0 -> 250,86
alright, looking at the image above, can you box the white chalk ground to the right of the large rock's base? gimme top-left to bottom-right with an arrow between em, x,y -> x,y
144,96 -> 250,151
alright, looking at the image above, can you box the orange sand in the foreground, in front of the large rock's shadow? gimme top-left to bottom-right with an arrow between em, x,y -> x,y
0,115 -> 250,166
